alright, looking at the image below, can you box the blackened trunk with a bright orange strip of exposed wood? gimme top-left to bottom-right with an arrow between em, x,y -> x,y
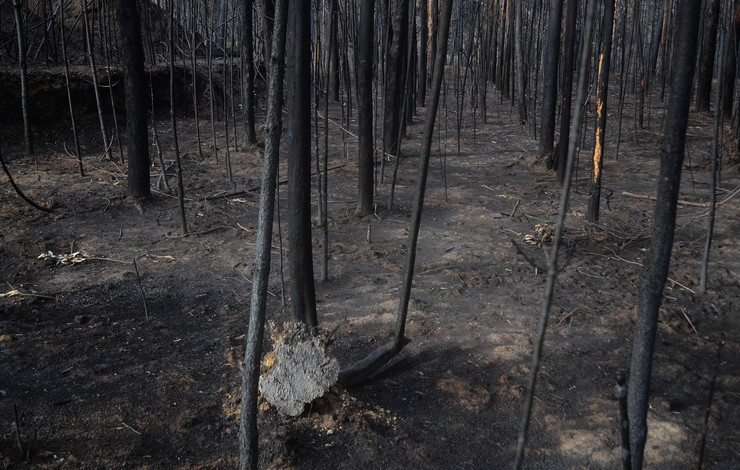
587,0 -> 614,222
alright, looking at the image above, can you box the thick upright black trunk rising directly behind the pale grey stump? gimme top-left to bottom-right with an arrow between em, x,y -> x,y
286,0 -> 318,326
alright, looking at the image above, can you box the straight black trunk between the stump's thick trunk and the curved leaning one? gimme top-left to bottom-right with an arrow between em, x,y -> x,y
357,0 -> 375,216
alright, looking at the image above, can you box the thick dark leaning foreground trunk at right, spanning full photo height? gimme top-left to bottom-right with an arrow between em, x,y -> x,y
627,0 -> 701,470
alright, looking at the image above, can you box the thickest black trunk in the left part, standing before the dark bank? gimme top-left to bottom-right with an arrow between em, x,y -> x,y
116,0 -> 151,198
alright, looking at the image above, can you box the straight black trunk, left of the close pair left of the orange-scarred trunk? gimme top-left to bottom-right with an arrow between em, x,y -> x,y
540,0 -> 563,158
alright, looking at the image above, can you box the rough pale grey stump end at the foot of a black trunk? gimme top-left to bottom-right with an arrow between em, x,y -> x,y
259,322 -> 339,416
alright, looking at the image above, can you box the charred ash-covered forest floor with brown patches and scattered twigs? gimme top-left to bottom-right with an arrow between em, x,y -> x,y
0,79 -> 740,469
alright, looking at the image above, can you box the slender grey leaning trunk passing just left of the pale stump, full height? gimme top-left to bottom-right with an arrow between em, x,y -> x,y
239,0 -> 288,470
